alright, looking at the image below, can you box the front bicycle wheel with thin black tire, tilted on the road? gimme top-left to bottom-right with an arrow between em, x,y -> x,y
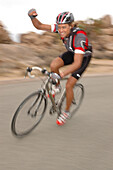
11,91 -> 47,137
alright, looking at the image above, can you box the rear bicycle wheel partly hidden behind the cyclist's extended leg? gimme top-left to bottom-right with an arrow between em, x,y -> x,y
59,83 -> 84,117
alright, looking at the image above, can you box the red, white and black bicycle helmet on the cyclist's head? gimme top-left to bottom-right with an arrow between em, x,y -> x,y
56,12 -> 74,24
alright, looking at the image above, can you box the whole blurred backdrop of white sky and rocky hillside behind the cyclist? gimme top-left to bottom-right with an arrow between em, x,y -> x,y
0,0 -> 113,79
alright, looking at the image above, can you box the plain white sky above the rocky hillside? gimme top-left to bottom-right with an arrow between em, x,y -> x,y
0,0 -> 113,41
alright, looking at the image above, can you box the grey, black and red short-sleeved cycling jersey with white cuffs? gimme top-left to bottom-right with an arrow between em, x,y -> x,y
51,24 -> 92,54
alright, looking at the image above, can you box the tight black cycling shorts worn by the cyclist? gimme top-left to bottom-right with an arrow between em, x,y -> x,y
59,51 -> 92,80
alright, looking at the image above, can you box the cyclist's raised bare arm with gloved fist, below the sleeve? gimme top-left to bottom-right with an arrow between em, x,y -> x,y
28,9 -> 51,32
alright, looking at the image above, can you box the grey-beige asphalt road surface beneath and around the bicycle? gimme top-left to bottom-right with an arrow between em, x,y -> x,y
0,76 -> 113,170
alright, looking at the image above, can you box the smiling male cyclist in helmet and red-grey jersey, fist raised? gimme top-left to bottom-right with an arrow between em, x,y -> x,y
28,9 -> 92,125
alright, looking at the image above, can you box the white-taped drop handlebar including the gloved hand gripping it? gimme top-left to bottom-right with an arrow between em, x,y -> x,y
25,66 -> 61,80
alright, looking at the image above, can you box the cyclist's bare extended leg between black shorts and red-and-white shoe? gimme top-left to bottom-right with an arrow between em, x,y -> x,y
65,76 -> 77,111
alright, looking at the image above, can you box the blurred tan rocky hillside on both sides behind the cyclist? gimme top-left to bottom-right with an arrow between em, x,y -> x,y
0,15 -> 113,77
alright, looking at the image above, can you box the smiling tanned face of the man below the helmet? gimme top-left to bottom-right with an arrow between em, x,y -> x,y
58,24 -> 71,38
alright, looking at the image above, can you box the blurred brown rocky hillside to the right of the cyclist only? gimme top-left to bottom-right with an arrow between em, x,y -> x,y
81,15 -> 113,59
